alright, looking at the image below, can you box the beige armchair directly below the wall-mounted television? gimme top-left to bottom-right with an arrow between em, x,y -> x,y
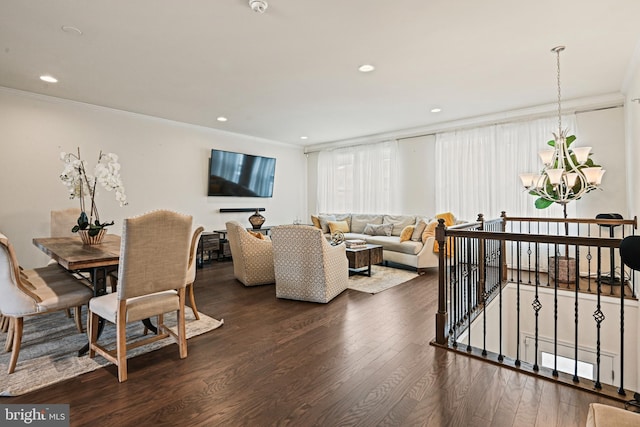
226,221 -> 276,286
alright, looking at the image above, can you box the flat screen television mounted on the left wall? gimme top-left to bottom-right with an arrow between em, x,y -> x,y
208,149 -> 276,197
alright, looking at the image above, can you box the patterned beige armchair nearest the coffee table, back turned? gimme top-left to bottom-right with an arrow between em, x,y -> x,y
271,225 -> 349,303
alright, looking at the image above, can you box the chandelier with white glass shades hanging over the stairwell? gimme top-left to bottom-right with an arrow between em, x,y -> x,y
520,46 -> 605,213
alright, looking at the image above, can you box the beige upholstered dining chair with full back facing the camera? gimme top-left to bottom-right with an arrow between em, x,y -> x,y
89,210 -> 192,382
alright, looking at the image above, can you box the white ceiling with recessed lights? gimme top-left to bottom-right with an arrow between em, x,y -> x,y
0,0 -> 640,145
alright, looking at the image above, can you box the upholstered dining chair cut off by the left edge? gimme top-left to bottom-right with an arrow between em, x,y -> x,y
0,233 -> 93,374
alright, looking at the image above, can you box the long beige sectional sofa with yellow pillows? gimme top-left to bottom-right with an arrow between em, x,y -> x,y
311,213 -> 452,273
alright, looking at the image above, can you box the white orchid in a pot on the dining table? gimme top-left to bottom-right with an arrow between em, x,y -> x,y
60,148 -> 127,236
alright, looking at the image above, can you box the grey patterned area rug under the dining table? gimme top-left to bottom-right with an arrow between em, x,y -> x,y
0,308 -> 224,396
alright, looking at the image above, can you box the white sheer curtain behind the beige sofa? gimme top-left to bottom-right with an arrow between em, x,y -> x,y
317,141 -> 399,213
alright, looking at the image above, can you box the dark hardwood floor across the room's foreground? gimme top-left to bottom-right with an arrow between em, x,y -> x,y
0,261 -> 622,427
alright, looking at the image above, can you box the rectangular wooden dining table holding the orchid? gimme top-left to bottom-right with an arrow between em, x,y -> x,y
33,234 -> 157,356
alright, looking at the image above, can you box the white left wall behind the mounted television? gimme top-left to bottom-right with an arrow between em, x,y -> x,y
0,88 -> 307,268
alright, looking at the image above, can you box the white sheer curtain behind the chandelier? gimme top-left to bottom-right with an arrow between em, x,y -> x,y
435,115 -> 580,220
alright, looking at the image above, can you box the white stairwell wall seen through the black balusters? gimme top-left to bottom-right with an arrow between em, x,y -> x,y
458,283 -> 639,390
